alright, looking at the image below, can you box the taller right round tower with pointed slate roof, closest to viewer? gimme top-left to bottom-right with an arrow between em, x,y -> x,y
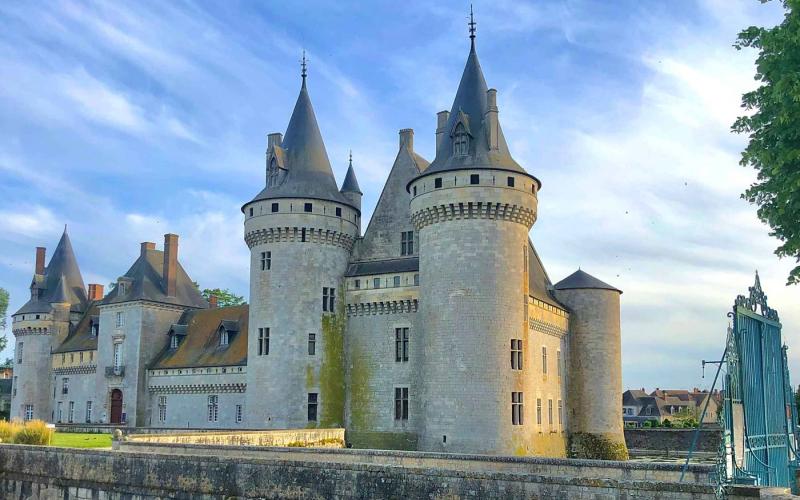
408,32 -> 540,454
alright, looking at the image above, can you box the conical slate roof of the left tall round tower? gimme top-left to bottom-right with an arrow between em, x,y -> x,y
245,76 -> 352,209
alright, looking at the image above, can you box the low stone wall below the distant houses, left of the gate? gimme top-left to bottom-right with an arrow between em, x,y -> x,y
625,427 -> 722,453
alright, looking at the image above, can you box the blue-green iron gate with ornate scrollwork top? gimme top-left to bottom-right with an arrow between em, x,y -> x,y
720,273 -> 797,490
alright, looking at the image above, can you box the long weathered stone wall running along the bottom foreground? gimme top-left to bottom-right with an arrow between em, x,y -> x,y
0,445 -> 736,500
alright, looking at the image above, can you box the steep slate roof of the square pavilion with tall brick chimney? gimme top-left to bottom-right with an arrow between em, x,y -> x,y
101,250 -> 208,308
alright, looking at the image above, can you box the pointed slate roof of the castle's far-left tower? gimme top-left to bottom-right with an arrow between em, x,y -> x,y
14,228 -> 86,315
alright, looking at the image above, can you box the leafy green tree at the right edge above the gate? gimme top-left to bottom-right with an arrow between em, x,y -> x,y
732,0 -> 800,285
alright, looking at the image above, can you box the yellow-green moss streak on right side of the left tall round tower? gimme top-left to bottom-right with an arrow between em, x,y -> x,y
318,283 -> 347,427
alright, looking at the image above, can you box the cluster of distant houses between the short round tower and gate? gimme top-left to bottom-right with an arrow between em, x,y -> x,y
622,388 -> 720,427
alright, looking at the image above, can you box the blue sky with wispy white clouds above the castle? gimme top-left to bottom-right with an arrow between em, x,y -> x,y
0,0 -> 800,389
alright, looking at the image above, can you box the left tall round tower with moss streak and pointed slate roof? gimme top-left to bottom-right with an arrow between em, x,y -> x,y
242,62 -> 361,428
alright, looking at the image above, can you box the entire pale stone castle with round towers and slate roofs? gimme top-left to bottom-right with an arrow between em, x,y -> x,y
12,25 -> 627,458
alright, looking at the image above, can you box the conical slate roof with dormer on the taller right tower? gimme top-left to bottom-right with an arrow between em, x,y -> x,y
412,40 -> 541,187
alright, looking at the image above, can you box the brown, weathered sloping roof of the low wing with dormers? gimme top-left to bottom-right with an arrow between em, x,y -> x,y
150,304 -> 250,369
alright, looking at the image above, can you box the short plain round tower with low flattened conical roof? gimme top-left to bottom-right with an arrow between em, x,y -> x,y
555,270 -> 628,460
